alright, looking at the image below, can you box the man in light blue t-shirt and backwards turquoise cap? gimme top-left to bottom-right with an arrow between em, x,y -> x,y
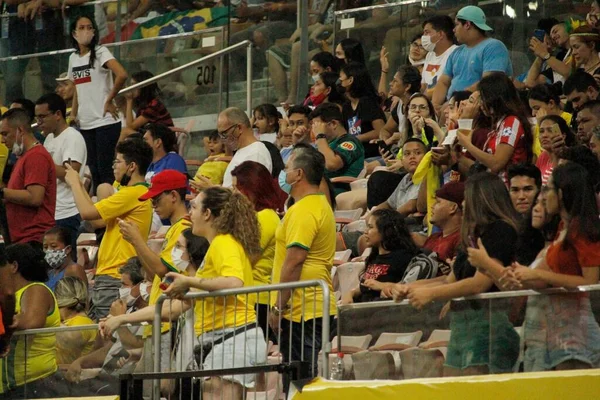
432,6 -> 513,111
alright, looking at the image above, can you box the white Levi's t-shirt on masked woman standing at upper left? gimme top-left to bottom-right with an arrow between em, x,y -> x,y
68,46 -> 118,130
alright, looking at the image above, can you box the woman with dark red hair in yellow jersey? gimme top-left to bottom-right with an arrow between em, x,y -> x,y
231,161 -> 283,343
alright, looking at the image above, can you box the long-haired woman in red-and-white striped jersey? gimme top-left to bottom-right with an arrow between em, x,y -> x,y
456,73 -> 533,183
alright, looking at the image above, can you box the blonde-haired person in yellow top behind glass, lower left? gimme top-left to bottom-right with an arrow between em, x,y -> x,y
54,276 -> 98,365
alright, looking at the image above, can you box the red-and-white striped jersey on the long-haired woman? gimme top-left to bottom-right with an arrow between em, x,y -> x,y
484,115 -> 527,182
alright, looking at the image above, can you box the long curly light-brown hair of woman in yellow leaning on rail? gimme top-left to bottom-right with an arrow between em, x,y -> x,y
202,186 -> 261,261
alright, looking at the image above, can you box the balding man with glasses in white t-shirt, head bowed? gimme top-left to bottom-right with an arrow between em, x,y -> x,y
217,107 -> 273,188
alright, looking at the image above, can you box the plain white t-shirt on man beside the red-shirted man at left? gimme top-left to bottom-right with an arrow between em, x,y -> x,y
44,127 -> 87,220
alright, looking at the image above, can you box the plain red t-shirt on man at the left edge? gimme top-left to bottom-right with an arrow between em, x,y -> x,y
5,144 -> 56,243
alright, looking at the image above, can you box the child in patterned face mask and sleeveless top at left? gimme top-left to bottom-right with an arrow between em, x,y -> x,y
43,226 -> 87,291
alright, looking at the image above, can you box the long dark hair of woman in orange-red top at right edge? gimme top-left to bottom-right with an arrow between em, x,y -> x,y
552,162 -> 600,246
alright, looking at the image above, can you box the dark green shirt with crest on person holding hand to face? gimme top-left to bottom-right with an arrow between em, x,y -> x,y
325,134 -> 365,195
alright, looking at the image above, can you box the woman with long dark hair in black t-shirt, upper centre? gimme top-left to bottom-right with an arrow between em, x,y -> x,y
340,62 -> 385,157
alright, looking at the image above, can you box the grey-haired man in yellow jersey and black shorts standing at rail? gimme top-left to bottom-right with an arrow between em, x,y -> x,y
270,146 -> 336,382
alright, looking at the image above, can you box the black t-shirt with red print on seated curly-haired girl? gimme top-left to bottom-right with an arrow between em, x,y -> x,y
357,249 -> 415,302
